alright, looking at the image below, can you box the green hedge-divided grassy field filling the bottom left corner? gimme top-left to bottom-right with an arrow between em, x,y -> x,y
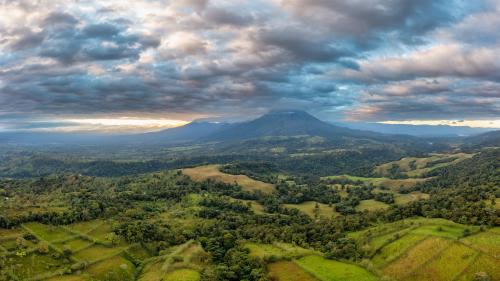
0,221 -> 136,281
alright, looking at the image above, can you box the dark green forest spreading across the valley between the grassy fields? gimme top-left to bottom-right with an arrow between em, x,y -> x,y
0,147 -> 500,280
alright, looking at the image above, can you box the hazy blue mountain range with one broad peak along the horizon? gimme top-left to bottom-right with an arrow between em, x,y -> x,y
0,110 -> 498,145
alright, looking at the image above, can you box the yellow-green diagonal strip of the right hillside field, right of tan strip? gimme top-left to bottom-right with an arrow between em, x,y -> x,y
406,243 -> 477,281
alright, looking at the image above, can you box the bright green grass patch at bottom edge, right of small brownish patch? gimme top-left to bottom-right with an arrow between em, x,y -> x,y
296,255 -> 378,281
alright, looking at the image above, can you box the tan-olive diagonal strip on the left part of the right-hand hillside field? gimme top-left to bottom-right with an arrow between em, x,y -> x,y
383,237 -> 451,280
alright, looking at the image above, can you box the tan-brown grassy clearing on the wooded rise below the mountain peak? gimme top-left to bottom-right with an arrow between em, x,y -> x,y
182,165 -> 274,193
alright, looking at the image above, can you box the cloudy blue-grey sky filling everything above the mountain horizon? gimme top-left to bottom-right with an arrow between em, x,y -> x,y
0,0 -> 500,131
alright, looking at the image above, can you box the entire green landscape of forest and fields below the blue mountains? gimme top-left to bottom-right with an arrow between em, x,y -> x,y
0,137 -> 500,281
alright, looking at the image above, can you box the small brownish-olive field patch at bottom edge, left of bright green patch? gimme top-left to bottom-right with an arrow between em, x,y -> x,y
267,261 -> 317,281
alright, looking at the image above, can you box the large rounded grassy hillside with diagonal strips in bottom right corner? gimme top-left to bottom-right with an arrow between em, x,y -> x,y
348,218 -> 500,281
